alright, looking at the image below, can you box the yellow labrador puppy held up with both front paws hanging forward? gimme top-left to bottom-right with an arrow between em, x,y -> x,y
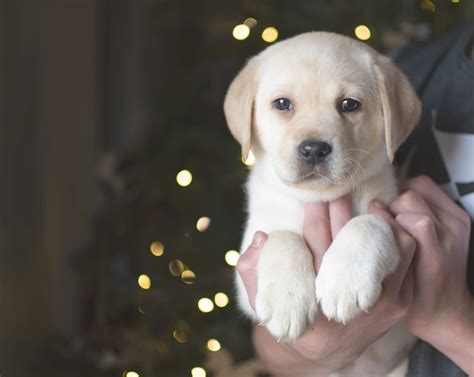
224,32 -> 420,374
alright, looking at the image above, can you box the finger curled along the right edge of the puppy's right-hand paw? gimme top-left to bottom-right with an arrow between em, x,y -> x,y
369,202 -> 416,295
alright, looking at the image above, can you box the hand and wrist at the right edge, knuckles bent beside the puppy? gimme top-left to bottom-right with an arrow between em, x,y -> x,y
390,176 -> 474,375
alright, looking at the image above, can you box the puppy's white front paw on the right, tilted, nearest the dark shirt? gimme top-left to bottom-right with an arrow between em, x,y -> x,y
316,215 -> 399,323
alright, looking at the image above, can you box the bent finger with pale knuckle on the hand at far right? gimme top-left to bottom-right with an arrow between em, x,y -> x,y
395,213 -> 442,274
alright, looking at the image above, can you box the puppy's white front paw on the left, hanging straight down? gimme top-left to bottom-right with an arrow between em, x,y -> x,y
255,231 -> 318,341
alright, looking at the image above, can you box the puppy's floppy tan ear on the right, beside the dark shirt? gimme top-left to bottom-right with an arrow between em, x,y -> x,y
375,55 -> 421,161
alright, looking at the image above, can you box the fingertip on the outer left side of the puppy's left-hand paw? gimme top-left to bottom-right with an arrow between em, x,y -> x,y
236,232 -> 268,310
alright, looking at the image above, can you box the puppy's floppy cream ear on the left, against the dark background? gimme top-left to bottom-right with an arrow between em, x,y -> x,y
224,57 -> 258,161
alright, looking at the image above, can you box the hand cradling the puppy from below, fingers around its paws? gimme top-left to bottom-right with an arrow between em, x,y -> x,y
237,197 -> 415,375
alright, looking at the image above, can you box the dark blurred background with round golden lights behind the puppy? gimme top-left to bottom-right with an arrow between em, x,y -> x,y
0,0 -> 474,377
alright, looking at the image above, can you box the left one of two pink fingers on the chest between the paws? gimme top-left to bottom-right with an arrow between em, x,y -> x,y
303,202 -> 332,272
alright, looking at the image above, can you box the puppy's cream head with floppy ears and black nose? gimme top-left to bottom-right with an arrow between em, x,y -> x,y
224,32 -> 420,188
